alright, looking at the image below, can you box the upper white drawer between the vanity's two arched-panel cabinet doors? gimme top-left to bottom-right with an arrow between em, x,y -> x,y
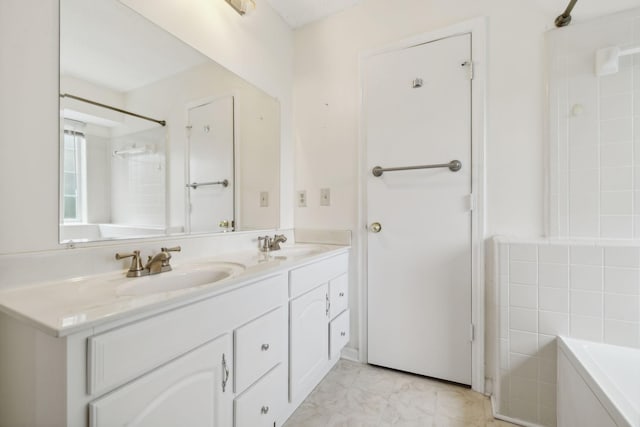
234,307 -> 287,393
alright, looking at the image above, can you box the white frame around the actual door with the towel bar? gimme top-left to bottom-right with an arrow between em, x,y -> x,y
356,17 -> 489,393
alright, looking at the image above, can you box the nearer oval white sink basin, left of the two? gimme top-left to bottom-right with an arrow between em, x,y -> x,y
116,262 -> 246,296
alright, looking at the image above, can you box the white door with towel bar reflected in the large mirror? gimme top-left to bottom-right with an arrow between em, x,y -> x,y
187,96 -> 234,233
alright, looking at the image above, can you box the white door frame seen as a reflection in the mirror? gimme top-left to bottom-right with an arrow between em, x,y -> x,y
184,90 -> 241,234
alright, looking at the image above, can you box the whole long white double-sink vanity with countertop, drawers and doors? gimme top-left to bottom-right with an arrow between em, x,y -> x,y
0,245 -> 349,427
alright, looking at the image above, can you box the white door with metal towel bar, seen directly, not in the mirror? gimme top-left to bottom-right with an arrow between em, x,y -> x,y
364,34 -> 471,384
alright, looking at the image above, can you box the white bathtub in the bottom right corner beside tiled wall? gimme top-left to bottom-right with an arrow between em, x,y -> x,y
557,337 -> 640,427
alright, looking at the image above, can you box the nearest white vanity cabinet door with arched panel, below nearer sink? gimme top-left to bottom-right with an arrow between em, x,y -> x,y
89,335 -> 233,427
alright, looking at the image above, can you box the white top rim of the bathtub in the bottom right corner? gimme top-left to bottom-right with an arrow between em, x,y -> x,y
557,336 -> 640,427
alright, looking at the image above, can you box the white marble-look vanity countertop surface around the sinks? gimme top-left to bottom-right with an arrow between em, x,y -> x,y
0,244 -> 349,337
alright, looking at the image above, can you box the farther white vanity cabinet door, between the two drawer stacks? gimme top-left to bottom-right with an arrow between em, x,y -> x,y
289,283 -> 329,401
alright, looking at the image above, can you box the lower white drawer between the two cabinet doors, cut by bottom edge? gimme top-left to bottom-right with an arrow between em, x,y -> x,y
233,365 -> 287,427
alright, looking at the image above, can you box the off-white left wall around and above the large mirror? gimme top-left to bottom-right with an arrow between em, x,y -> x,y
0,0 -> 293,254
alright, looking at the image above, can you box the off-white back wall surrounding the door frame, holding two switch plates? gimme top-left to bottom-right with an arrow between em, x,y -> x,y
294,0 -> 553,362
